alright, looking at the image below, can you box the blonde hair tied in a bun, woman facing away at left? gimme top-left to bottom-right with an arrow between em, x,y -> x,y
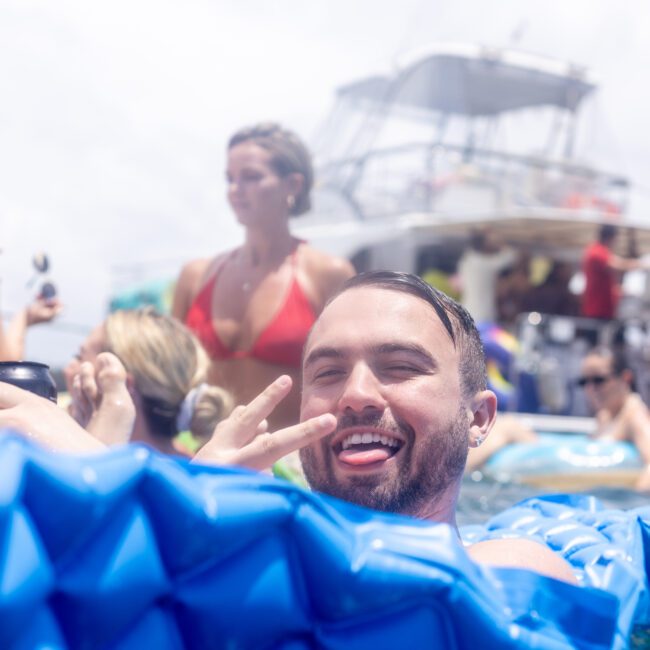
104,307 -> 233,441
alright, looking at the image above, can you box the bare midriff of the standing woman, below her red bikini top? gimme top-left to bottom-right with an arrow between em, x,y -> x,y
209,358 -> 300,431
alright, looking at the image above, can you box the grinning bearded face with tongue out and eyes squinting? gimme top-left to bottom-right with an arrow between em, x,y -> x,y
301,286 -> 471,516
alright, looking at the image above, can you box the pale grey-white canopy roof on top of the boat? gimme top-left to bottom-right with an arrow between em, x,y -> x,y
338,44 -> 596,116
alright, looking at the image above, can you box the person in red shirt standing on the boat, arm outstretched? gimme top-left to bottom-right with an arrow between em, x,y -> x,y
582,224 -> 642,319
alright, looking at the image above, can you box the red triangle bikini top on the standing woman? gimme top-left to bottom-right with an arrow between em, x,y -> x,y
185,252 -> 316,368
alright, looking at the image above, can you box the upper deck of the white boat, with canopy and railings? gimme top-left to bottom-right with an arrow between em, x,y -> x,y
294,44 -> 650,272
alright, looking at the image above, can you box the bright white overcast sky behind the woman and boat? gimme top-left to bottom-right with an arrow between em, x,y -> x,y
0,0 -> 650,365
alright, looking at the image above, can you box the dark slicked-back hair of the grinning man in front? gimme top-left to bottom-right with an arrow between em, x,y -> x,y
329,271 -> 487,397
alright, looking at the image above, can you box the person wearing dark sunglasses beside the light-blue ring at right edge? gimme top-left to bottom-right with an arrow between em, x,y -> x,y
576,346 -> 650,490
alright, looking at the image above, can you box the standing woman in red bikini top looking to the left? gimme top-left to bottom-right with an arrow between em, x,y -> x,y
172,124 -> 354,431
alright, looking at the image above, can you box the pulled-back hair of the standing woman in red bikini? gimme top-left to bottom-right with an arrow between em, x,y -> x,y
228,122 -> 314,217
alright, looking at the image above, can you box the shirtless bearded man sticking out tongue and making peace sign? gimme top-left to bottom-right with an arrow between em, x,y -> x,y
0,272 -> 575,582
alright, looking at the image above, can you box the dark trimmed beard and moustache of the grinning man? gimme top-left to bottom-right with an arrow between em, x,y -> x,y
300,408 -> 468,516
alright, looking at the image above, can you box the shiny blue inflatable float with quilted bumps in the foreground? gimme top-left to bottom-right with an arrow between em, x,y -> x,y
0,435 -> 650,650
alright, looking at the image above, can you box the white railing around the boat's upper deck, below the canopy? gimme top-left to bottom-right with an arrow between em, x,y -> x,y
319,142 -> 628,219
